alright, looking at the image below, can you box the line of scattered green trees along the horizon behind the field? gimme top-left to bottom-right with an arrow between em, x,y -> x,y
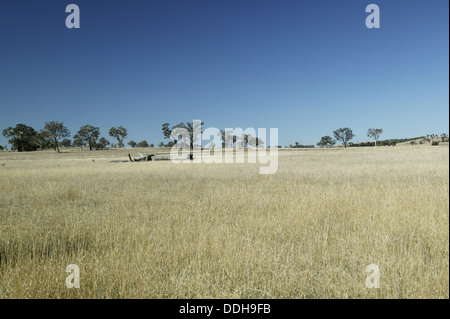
0,121 -> 448,153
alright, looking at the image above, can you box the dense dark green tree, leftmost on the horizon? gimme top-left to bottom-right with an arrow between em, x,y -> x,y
2,124 -> 38,152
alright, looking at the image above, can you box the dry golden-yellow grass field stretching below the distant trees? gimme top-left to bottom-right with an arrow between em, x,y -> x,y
0,146 -> 449,298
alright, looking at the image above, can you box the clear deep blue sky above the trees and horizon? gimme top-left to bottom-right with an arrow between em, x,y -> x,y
0,0 -> 449,145
